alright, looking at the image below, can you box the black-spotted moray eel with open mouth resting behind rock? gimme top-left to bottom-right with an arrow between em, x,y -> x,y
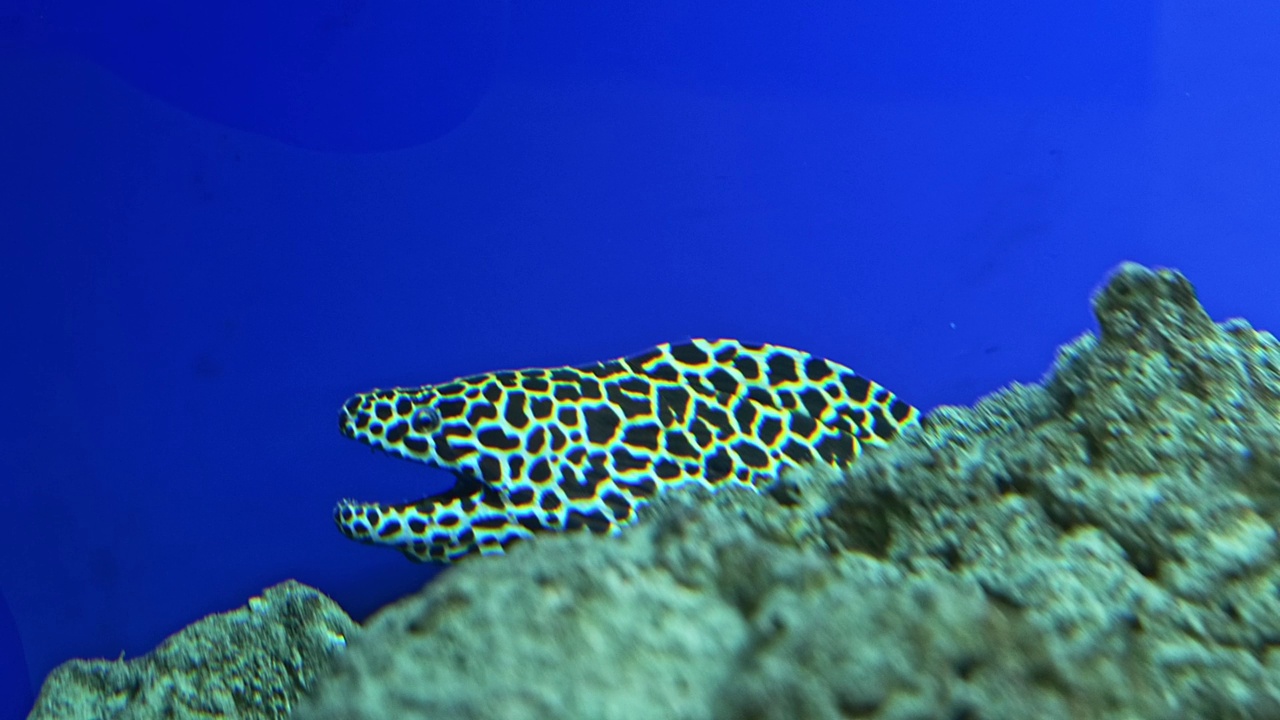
334,340 -> 919,562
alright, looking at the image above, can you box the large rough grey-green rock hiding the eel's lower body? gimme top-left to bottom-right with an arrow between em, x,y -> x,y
294,265 -> 1280,720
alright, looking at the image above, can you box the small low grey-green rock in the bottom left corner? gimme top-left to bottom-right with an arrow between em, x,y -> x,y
29,580 -> 357,720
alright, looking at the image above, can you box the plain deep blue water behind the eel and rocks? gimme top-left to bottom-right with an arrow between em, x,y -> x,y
0,0 -> 1280,715
